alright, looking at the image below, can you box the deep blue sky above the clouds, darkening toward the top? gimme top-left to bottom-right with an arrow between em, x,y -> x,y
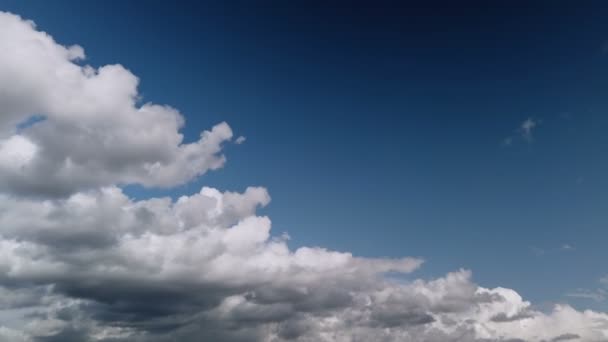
0,0 -> 608,308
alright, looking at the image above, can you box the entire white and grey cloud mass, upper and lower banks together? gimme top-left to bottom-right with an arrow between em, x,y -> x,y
0,13 -> 608,342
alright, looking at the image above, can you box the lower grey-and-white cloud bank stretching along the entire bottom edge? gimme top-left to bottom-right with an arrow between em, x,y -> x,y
0,187 -> 608,342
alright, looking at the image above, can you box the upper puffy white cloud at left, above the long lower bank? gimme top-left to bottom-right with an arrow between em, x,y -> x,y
0,13 -> 232,196
